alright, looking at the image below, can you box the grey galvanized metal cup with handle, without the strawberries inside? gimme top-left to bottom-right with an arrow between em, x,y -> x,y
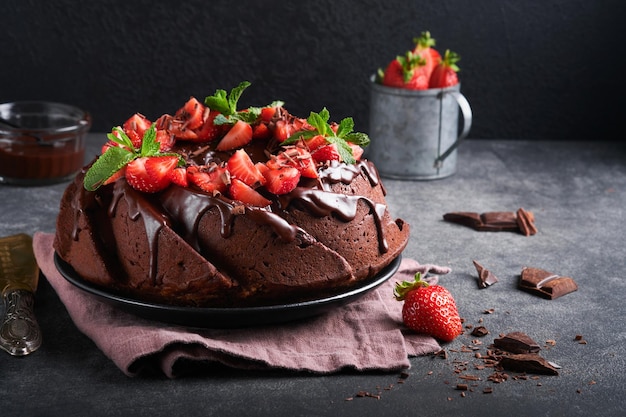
366,76 -> 472,180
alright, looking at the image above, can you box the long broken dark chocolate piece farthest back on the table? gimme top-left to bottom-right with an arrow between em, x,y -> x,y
443,208 -> 537,236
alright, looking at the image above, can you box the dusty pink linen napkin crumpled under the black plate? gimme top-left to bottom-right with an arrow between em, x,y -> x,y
33,233 -> 450,378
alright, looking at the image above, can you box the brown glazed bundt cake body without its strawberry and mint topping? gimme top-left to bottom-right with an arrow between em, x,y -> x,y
54,99 -> 410,307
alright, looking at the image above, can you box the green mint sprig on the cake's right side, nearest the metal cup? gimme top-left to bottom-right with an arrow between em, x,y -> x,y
282,107 -> 370,164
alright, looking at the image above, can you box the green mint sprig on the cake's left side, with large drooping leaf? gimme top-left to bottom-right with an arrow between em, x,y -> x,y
83,123 -> 180,191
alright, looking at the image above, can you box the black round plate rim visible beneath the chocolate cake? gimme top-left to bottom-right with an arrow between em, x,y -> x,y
54,253 -> 402,328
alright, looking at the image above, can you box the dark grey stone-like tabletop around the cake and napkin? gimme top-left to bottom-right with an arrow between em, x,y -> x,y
0,134 -> 626,417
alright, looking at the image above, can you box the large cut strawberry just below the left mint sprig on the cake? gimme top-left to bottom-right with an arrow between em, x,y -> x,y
126,156 -> 178,193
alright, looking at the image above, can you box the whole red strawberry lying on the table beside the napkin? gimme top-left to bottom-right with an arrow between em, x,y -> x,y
394,272 -> 463,342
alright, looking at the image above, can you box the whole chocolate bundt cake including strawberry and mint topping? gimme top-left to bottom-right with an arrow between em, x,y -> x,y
54,83 -> 409,307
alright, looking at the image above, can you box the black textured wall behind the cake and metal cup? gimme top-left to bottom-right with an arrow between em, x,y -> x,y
0,0 -> 626,141
